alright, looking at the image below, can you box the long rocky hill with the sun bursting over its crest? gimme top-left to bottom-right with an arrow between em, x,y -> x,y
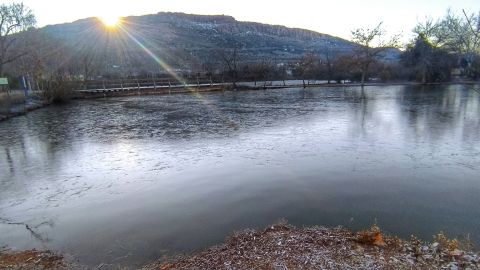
36,12 -> 398,75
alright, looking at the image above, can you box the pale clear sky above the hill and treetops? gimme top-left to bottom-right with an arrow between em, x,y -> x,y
0,0 -> 480,40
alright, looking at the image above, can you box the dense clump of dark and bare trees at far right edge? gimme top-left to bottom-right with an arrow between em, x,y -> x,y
402,10 -> 480,83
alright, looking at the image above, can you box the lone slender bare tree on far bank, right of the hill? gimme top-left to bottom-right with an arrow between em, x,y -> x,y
352,22 -> 399,86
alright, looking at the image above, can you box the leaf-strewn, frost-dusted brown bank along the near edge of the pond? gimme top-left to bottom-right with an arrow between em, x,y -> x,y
0,224 -> 480,270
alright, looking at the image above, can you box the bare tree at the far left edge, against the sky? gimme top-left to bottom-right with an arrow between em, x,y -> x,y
0,3 -> 36,75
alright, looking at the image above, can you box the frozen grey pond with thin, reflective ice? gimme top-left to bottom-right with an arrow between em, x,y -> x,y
0,86 -> 480,266
